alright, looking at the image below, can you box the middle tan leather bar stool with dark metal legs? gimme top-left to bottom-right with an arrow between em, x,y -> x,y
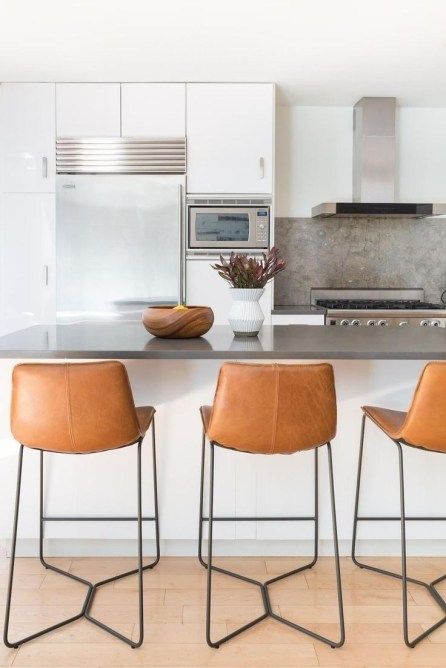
198,363 -> 345,647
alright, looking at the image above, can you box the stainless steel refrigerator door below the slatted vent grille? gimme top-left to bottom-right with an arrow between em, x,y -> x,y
56,174 -> 185,321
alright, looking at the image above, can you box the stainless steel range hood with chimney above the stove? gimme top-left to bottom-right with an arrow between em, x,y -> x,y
311,97 -> 446,218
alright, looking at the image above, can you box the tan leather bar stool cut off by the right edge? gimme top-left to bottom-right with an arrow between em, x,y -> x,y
352,362 -> 446,647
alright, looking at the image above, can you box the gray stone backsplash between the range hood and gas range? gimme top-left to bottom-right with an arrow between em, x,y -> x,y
275,218 -> 446,305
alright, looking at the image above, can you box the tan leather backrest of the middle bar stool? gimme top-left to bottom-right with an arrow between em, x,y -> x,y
208,363 -> 336,454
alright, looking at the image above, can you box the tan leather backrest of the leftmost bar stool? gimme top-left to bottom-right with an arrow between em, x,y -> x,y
11,362 -> 140,453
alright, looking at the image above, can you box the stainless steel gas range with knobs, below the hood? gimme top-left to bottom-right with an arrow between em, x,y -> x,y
311,288 -> 446,327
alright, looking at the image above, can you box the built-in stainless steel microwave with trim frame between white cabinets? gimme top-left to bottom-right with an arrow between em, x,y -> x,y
187,199 -> 270,250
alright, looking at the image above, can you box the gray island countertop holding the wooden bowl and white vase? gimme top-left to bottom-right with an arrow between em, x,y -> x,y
0,321 -> 446,360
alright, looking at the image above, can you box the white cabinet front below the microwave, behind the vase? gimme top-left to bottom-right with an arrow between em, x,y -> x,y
186,256 -> 273,325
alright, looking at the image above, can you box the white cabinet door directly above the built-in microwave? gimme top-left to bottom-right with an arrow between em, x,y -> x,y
187,83 -> 274,193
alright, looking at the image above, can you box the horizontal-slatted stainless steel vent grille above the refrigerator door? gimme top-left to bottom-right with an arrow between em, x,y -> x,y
56,137 -> 186,174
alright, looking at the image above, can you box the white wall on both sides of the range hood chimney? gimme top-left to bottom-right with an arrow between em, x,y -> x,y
276,107 -> 446,217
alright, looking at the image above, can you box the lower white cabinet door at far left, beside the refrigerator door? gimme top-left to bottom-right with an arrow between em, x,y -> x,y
0,193 -> 56,334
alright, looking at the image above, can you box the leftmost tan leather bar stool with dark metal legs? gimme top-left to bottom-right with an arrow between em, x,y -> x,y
3,362 -> 160,647
